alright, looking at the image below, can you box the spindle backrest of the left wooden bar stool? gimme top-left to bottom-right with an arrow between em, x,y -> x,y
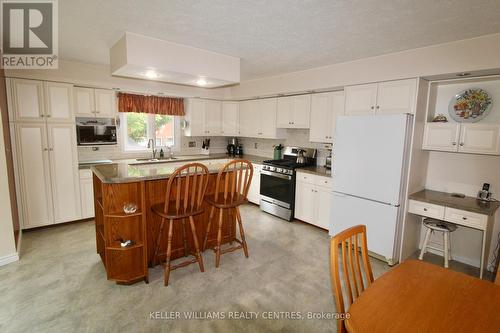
164,163 -> 209,215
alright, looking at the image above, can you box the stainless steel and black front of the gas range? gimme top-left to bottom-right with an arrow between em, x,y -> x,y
260,169 -> 295,221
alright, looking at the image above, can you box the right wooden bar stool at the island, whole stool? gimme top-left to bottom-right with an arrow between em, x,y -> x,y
203,160 -> 253,267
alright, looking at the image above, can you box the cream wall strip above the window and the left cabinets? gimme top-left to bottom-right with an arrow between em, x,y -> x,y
5,60 -> 230,98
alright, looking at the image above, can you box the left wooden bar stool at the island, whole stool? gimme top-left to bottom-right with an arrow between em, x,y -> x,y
151,163 -> 209,286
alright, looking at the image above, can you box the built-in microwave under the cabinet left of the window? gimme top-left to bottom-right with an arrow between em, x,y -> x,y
76,118 -> 117,146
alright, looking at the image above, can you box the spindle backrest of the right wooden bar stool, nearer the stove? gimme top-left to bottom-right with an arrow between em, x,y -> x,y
215,160 -> 253,205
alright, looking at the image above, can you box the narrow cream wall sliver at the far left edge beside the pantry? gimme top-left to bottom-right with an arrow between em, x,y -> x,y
0,111 -> 17,265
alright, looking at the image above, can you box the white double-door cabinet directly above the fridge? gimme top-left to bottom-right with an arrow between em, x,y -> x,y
345,79 -> 417,115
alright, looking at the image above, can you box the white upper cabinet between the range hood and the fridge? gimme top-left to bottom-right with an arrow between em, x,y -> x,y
309,91 -> 344,143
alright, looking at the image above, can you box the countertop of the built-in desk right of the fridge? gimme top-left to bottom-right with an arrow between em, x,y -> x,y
409,190 -> 500,216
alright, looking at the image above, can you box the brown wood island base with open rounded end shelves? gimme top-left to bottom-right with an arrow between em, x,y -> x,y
93,174 -> 236,284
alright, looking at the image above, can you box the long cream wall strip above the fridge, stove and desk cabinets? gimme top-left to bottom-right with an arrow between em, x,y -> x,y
231,34 -> 500,98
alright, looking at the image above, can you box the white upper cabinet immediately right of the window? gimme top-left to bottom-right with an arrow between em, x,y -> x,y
184,98 -> 222,136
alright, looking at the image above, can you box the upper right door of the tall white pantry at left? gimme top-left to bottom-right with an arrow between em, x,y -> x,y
44,82 -> 75,123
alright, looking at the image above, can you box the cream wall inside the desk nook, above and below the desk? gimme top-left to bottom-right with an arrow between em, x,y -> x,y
425,152 -> 500,267
